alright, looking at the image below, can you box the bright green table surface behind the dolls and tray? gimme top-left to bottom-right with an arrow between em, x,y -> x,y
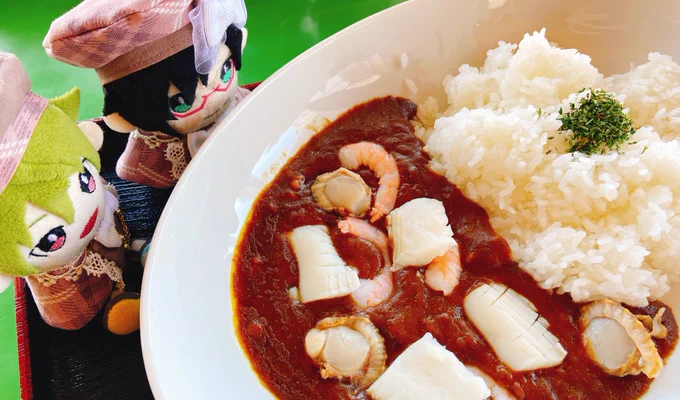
0,0 -> 402,400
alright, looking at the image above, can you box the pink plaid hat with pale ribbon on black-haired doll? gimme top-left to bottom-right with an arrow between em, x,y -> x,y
43,0 -> 247,85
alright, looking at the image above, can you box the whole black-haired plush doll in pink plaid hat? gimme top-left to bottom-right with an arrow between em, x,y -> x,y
43,0 -> 249,188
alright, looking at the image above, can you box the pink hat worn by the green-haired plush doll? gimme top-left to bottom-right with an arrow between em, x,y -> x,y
0,52 -> 48,194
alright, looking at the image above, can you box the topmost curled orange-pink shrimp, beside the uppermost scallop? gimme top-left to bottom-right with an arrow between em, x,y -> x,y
338,142 -> 400,222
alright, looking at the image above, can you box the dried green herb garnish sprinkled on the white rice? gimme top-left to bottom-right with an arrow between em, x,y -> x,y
558,88 -> 635,154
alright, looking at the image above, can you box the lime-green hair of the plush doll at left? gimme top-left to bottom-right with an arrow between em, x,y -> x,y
0,89 -> 100,276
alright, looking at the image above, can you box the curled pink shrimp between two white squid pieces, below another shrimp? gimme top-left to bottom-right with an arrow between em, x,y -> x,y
338,217 -> 394,308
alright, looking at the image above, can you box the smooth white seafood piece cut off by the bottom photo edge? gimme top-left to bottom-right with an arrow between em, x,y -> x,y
368,332 -> 491,400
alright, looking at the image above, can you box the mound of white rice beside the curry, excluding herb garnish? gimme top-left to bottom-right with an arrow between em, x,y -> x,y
415,31 -> 680,305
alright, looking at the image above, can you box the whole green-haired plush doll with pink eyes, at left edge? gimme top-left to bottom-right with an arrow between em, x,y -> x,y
0,53 -> 139,334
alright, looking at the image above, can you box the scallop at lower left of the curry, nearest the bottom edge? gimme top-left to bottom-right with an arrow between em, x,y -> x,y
305,317 -> 387,388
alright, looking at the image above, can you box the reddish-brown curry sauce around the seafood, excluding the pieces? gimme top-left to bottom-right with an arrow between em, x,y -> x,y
232,97 -> 678,400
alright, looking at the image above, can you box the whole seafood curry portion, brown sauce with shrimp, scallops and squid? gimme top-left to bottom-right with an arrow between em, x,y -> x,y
232,97 -> 678,400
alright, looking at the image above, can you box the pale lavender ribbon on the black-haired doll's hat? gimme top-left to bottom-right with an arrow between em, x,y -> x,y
189,0 -> 248,74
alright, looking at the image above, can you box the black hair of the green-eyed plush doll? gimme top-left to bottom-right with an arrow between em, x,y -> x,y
103,24 -> 243,138
